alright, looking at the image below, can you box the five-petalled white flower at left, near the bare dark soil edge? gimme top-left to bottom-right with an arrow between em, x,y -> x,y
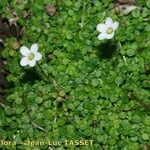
20,43 -> 42,67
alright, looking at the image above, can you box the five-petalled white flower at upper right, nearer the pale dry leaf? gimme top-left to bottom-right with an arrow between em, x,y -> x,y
96,17 -> 119,40
